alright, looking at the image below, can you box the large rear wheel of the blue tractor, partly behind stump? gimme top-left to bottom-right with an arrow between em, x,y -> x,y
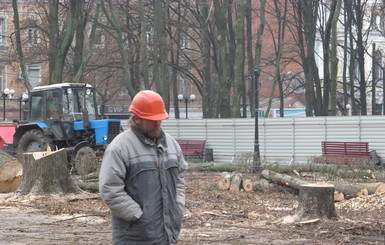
16,129 -> 52,159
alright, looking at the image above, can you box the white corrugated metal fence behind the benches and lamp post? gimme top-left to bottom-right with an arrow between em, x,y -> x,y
158,116 -> 385,163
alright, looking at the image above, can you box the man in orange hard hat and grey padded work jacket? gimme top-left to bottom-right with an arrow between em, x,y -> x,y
99,90 -> 187,245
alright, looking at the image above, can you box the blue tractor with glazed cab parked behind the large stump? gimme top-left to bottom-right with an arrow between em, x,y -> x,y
13,83 -> 121,172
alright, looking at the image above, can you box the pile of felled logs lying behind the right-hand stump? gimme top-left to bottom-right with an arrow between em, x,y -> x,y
218,169 -> 385,201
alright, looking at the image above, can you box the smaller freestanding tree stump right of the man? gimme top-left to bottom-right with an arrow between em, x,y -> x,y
297,184 -> 337,219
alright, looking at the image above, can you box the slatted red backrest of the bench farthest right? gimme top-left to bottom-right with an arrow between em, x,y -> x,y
322,141 -> 369,156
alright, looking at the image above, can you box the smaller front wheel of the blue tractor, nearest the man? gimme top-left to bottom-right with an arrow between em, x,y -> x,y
74,146 -> 98,176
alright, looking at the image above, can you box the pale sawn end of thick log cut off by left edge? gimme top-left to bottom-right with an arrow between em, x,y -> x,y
0,151 -> 23,193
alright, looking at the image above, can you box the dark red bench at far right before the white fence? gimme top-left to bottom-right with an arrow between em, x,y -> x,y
315,141 -> 369,164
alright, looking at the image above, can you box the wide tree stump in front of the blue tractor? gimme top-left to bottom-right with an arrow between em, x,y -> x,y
18,148 -> 77,195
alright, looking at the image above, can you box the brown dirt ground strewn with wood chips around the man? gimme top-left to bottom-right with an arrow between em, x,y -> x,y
0,172 -> 385,245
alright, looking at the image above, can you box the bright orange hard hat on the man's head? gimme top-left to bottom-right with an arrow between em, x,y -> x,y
128,90 -> 168,120
